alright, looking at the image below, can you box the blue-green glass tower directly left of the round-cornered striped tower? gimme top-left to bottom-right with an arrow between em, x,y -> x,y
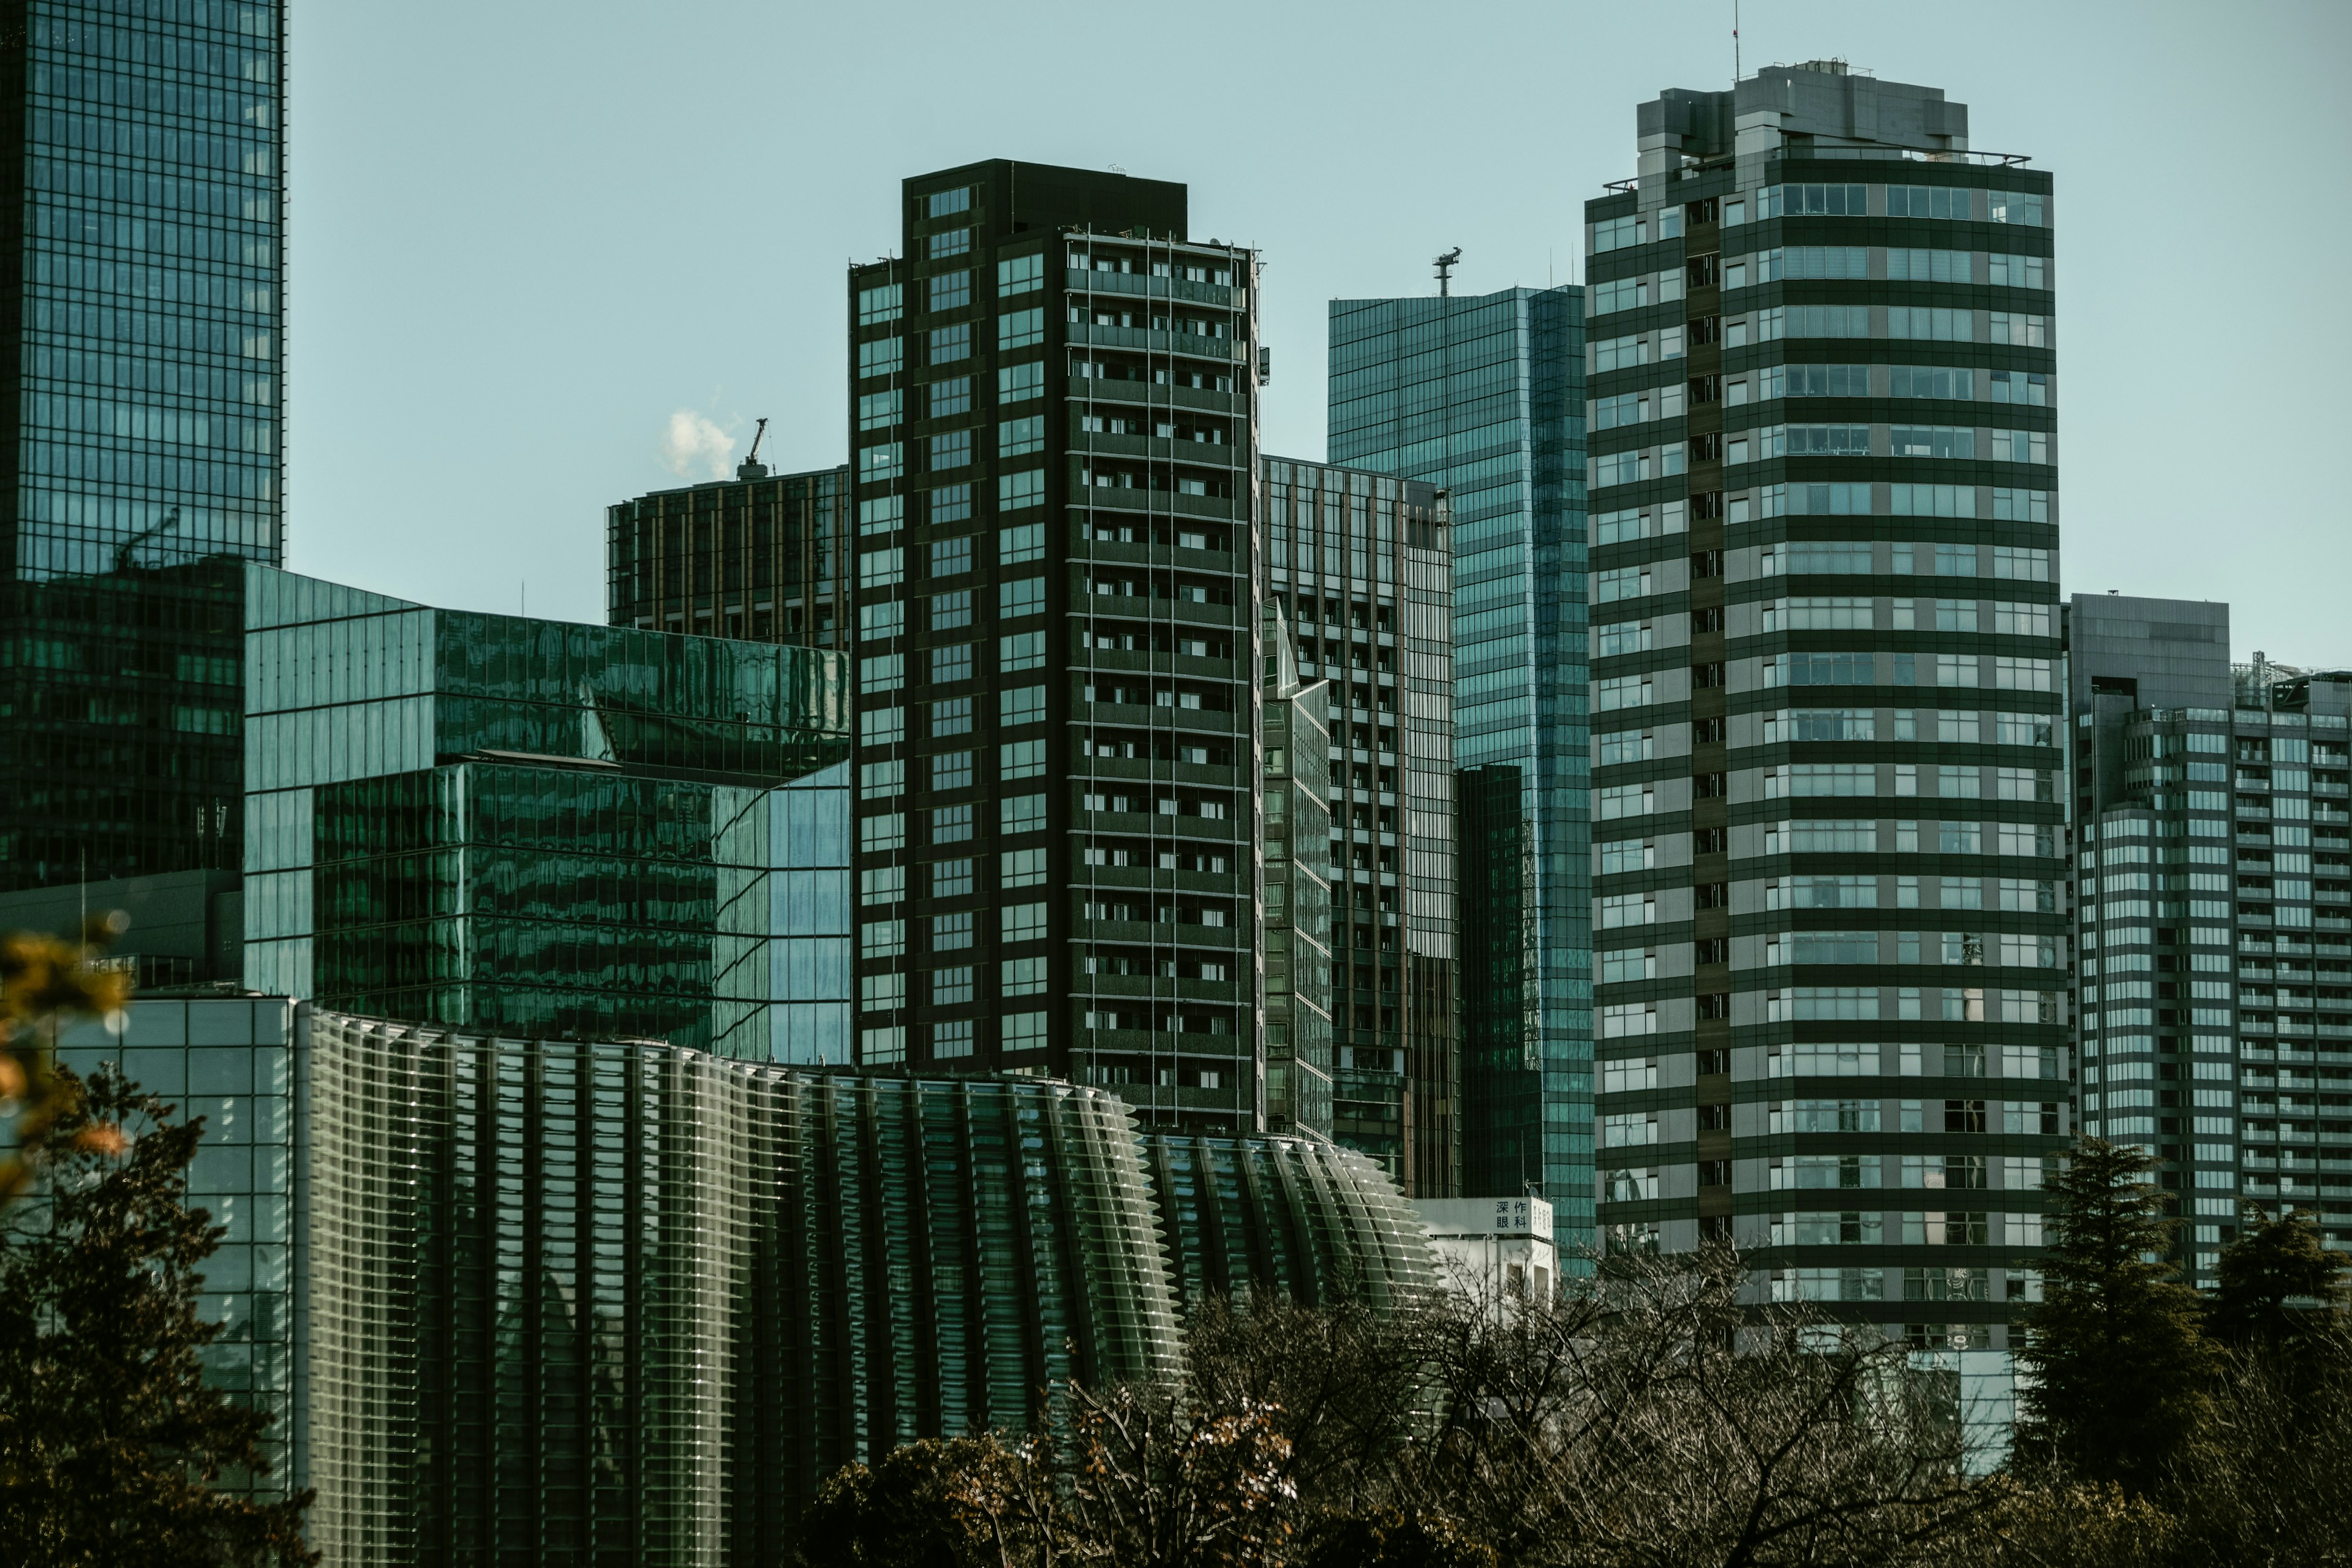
1329,289 -> 1593,1246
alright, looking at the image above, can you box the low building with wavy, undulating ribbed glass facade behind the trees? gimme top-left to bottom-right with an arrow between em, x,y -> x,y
45,997 -> 1437,1563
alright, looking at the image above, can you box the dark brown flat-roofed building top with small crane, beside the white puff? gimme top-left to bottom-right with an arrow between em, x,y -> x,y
605,458 -> 854,649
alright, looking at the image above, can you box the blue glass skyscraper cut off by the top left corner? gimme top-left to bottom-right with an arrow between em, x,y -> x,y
0,0 -> 285,907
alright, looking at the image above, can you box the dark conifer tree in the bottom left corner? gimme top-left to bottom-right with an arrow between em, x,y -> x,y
0,1067 -> 317,1568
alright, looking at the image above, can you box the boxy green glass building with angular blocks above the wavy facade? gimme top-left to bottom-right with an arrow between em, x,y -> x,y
244,567 -> 849,1063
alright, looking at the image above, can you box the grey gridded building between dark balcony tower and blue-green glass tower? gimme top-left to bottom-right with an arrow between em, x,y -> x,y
1261,458 -> 1461,1197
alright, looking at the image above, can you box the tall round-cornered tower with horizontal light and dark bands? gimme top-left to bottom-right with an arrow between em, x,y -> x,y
1585,61 -> 2072,1371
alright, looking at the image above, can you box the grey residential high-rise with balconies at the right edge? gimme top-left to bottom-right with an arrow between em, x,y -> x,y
2067,595 -> 2352,1286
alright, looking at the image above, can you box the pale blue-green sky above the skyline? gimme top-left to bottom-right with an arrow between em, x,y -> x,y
287,0 -> 2352,663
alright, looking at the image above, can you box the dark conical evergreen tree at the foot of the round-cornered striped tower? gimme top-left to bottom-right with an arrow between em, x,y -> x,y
2018,1138 -> 2215,1495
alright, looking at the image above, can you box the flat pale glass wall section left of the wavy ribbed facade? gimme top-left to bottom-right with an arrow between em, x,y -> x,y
56,997 -> 298,1498
